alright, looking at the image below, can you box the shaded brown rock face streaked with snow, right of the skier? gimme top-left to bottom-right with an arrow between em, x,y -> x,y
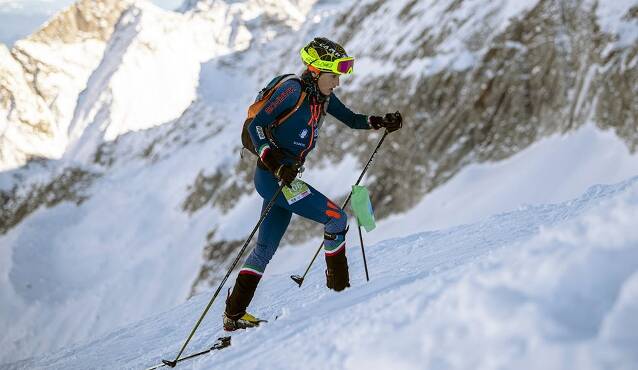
306,0 -> 638,220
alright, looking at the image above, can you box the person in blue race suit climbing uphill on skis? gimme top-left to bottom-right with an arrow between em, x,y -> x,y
223,37 -> 402,331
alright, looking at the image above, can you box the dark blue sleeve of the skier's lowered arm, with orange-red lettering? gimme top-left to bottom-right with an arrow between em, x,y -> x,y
248,80 -> 301,157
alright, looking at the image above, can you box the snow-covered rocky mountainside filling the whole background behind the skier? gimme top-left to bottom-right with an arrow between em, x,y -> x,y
0,0 -> 638,367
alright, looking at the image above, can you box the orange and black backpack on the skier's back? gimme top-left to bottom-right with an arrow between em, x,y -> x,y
241,74 -> 306,156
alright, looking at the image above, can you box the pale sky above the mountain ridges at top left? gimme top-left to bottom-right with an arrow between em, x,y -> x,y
0,0 -> 188,46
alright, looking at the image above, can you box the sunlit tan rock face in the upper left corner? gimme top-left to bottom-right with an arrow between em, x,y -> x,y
0,0 -> 131,170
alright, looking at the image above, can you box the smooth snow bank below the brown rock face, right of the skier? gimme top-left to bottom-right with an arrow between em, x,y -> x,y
370,123 -> 638,241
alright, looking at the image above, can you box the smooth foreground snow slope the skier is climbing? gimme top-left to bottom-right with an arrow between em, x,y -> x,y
5,177 -> 638,369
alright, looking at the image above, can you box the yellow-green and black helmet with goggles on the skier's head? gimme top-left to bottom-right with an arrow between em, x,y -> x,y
300,37 -> 354,74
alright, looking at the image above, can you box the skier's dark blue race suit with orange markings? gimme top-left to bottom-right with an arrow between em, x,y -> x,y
240,79 -> 370,277
